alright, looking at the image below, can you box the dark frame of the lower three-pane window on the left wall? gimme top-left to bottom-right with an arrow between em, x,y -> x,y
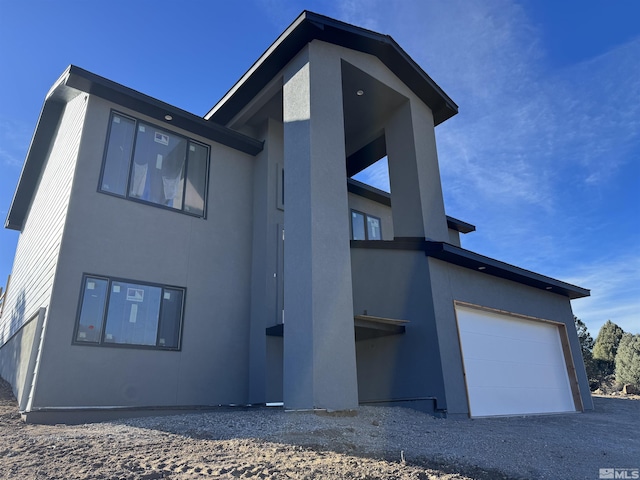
71,273 -> 187,352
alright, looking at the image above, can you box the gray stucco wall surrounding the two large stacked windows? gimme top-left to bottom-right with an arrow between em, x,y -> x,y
26,97 -> 253,410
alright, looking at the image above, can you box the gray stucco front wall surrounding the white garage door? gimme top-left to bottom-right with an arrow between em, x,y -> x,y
428,258 -> 593,415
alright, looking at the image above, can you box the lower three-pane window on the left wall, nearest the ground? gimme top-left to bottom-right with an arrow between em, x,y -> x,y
74,275 -> 185,350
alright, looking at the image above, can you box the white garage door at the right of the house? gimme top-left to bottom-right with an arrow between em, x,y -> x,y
456,305 -> 575,417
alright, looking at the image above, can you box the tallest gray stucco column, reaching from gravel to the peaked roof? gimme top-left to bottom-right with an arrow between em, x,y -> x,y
283,41 -> 358,410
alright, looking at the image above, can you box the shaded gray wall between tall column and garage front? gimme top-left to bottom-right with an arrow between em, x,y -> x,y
351,248 -> 448,411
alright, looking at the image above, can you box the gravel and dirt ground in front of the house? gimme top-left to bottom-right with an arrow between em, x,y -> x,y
0,380 -> 640,480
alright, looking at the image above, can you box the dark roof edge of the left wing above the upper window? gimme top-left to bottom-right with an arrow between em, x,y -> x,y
5,65 -> 264,230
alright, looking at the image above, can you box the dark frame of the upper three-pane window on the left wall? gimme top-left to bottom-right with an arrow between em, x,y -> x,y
97,109 -> 211,219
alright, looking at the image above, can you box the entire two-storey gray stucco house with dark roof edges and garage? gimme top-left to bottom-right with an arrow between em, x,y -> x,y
0,12 -> 593,422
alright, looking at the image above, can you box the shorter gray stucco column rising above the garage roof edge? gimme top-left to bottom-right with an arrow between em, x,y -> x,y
385,101 -> 449,242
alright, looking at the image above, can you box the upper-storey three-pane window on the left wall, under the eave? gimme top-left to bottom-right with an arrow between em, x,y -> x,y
100,112 -> 209,217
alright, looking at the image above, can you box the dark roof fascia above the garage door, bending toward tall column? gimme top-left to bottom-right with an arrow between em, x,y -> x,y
351,238 -> 591,300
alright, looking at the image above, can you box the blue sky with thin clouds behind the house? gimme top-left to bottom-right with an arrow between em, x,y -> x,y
0,0 -> 640,337
